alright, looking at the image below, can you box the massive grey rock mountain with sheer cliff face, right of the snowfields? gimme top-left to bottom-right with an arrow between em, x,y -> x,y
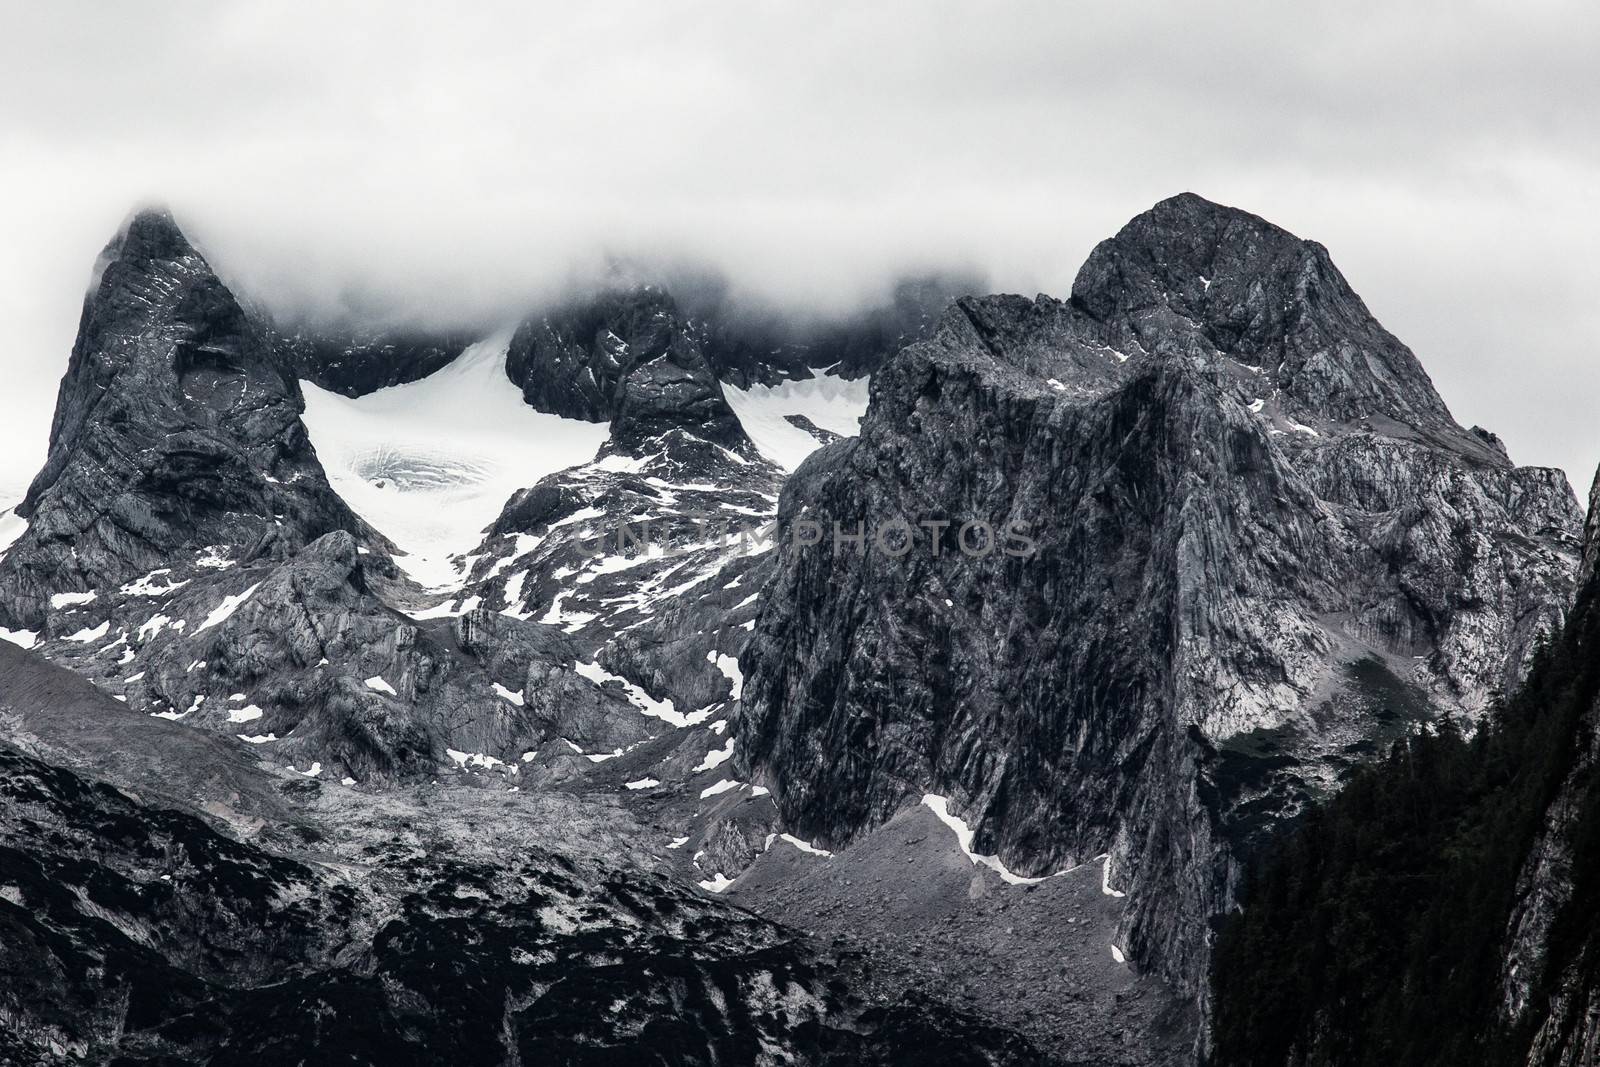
739,195 -> 1579,992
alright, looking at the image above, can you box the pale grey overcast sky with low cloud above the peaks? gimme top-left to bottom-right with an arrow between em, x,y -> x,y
0,0 -> 1600,491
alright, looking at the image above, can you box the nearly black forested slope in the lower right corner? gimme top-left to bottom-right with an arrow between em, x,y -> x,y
1213,463 -> 1600,1067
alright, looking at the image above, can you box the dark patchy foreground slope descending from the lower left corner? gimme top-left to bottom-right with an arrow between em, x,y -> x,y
0,645 -> 1051,1065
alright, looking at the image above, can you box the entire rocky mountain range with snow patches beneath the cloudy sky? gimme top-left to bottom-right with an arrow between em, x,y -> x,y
0,194 -> 1600,1064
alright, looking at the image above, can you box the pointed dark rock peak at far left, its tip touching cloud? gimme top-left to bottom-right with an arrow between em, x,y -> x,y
0,210 -> 371,630
